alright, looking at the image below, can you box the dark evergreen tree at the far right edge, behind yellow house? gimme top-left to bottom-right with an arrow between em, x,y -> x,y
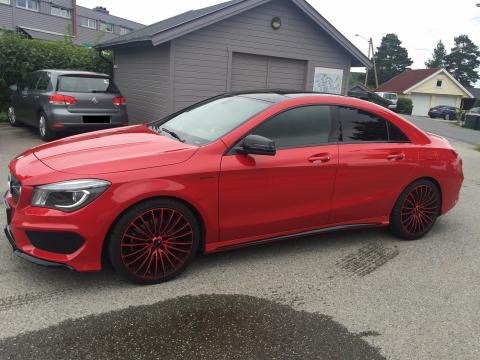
446,35 -> 480,86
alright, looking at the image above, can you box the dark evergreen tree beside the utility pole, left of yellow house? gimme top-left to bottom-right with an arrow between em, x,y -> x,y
368,34 -> 413,84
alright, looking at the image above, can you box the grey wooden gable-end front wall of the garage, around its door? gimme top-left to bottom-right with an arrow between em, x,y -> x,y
171,0 -> 351,110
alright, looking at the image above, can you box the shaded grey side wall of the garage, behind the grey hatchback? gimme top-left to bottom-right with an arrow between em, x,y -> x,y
114,44 -> 170,124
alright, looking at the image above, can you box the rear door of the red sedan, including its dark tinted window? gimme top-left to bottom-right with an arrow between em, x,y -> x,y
330,107 -> 418,224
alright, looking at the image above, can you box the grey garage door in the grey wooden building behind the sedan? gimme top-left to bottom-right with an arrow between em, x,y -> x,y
231,53 -> 307,91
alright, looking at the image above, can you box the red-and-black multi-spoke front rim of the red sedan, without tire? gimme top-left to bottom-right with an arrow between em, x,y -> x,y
120,208 -> 194,281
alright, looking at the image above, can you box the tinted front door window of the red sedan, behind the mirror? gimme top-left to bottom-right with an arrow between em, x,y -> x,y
253,106 -> 332,149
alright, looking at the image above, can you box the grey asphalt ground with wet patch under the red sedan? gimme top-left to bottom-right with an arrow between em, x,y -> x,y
0,125 -> 480,360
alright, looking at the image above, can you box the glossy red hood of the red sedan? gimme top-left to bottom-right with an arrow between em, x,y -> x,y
33,125 -> 198,175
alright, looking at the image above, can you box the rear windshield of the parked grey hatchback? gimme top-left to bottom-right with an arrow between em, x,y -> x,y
58,75 -> 119,93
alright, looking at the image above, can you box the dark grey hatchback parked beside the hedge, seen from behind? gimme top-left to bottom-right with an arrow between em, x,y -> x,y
8,70 -> 128,141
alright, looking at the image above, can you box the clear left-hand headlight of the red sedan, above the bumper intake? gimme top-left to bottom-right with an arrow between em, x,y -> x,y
30,179 -> 111,212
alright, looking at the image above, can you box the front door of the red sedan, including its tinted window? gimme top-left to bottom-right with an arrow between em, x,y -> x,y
219,106 -> 338,244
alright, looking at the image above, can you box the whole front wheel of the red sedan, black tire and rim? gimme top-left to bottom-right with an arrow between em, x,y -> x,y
107,198 -> 201,285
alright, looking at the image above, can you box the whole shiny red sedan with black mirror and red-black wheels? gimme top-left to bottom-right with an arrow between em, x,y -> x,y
1,92 -> 463,284
